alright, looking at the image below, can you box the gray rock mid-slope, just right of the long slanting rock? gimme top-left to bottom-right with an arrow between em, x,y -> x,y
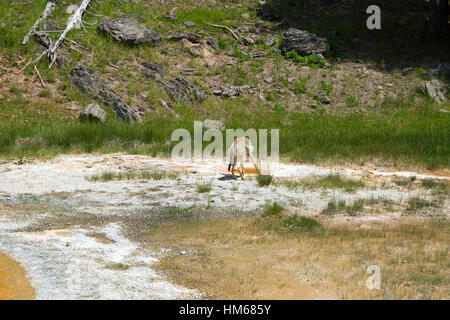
157,77 -> 207,103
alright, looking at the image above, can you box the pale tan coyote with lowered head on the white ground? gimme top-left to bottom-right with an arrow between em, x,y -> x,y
228,137 -> 259,180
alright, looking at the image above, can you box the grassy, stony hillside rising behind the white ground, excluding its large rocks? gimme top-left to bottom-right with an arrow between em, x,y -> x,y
0,0 -> 450,169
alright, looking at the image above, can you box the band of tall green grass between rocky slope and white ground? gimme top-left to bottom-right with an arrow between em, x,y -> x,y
0,93 -> 450,170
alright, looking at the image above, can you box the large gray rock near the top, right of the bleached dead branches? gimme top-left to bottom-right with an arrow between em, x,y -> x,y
97,17 -> 162,45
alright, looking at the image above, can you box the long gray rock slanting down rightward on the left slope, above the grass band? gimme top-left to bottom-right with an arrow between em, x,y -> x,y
68,64 -> 140,122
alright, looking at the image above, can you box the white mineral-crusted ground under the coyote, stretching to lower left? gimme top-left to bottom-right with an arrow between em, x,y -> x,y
0,154 -> 450,299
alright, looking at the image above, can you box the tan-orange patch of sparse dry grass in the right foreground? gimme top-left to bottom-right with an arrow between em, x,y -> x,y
150,216 -> 450,299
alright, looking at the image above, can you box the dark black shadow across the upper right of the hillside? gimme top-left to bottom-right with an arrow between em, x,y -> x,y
257,0 -> 450,70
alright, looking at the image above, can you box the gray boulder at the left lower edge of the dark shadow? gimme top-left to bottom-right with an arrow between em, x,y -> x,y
280,28 -> 330,56
